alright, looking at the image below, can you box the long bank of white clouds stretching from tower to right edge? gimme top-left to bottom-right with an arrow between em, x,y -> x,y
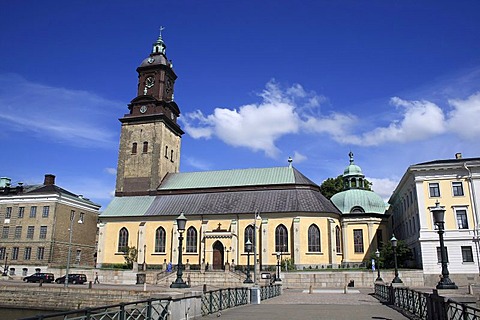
183,80 -> 480,157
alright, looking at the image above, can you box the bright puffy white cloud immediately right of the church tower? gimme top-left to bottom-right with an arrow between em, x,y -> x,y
182,81 -> 307,157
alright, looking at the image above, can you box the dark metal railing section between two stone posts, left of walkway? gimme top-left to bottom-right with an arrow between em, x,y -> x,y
202,288 -> 249,316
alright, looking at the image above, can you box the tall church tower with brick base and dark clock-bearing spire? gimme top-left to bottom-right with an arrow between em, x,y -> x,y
115,28 -> 184,196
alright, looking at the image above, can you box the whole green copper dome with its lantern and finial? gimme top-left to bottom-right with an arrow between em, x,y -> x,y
331,152 -> 388,214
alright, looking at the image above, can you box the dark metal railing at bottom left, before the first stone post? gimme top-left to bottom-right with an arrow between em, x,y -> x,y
20,299 -> 171,320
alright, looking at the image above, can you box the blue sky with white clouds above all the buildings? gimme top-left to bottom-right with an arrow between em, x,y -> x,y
0,0 -> 480,209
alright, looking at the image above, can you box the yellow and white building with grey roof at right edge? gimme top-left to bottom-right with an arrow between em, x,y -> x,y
389,153 -> 480,283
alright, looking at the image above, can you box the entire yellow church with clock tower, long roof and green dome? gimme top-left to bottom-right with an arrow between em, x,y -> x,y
97,34 -> 390,270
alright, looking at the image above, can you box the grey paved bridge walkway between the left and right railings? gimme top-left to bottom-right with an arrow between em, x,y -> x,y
205,289 -> 408,320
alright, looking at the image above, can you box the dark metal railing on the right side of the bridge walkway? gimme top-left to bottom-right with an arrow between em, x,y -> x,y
375,284 -> 480,320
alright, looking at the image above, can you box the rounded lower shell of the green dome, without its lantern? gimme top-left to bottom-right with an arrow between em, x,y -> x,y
331,189 -> 388,214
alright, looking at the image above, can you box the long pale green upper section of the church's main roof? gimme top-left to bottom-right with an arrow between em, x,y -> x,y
158,167 -> 315,190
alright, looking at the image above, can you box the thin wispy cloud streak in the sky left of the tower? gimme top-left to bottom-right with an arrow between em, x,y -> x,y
0,74 -> 118,148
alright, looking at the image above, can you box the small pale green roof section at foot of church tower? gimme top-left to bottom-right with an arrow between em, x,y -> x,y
100,196 -> 155,218
